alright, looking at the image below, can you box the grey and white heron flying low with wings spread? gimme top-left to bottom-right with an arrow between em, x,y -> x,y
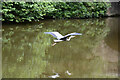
44,32 -> 82,46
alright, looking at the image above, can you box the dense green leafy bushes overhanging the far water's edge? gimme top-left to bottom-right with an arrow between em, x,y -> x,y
2,2 -> 110,23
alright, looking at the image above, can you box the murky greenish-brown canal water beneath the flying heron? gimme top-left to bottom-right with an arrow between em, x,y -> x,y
2,17 -> 120,78
